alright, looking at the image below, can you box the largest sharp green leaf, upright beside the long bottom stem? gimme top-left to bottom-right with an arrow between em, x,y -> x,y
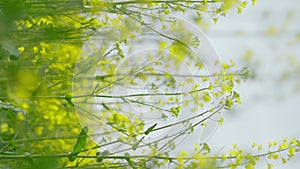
69,126 -> 88,162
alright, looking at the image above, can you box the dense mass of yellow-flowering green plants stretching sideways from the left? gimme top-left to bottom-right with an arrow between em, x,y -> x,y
0,0 -> 299,169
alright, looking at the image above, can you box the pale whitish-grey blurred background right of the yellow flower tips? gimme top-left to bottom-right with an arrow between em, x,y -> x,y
205,0 -> 300,169
